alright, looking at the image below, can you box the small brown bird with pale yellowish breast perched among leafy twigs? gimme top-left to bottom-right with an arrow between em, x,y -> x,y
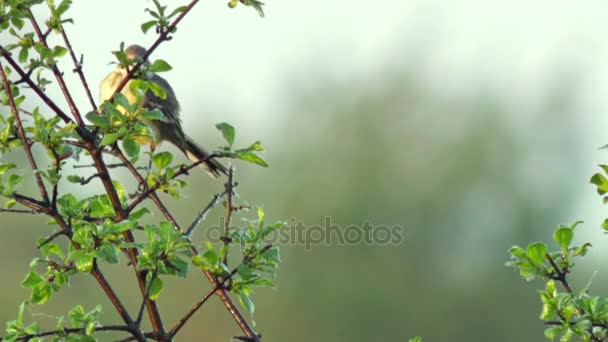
100,45 -> 228,177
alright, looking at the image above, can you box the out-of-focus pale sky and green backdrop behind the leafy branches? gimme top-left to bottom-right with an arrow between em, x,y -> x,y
0,0 -> 608,342
